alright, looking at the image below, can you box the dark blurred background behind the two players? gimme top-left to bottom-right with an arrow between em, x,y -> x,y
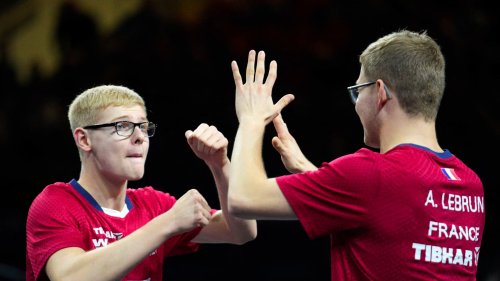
0,0 -> 500,281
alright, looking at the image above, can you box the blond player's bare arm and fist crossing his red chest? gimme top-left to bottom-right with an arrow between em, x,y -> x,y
46,189 -> 211,280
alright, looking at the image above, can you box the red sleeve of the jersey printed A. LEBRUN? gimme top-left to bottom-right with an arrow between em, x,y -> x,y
276,149 -> 380,239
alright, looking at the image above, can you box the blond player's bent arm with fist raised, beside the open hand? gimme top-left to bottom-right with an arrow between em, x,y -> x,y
186,123 -> 257,244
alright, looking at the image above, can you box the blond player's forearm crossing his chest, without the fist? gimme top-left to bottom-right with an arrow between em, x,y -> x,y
47,213 -> 175,280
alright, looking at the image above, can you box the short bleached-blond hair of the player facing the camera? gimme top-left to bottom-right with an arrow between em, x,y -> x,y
68,85 -> 146,131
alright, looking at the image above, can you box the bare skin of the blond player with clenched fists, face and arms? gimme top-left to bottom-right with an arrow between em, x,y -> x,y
46,106 -> 257,280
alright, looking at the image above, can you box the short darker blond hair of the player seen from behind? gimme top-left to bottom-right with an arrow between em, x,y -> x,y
359,30 -> 445,120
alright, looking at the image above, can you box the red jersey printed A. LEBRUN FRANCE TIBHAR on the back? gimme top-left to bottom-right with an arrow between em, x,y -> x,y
277,145 -> 485,281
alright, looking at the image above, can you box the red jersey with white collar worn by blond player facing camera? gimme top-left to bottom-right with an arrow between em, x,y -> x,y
26,180 -> 204,281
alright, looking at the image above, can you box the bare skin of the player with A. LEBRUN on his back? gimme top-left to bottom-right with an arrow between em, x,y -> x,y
229,50 -> 443,220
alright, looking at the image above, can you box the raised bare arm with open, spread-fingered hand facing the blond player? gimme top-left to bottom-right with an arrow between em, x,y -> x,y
229,50 -> 296,219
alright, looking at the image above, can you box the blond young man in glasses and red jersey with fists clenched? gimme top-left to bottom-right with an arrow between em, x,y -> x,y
26,85 -> 257,281
